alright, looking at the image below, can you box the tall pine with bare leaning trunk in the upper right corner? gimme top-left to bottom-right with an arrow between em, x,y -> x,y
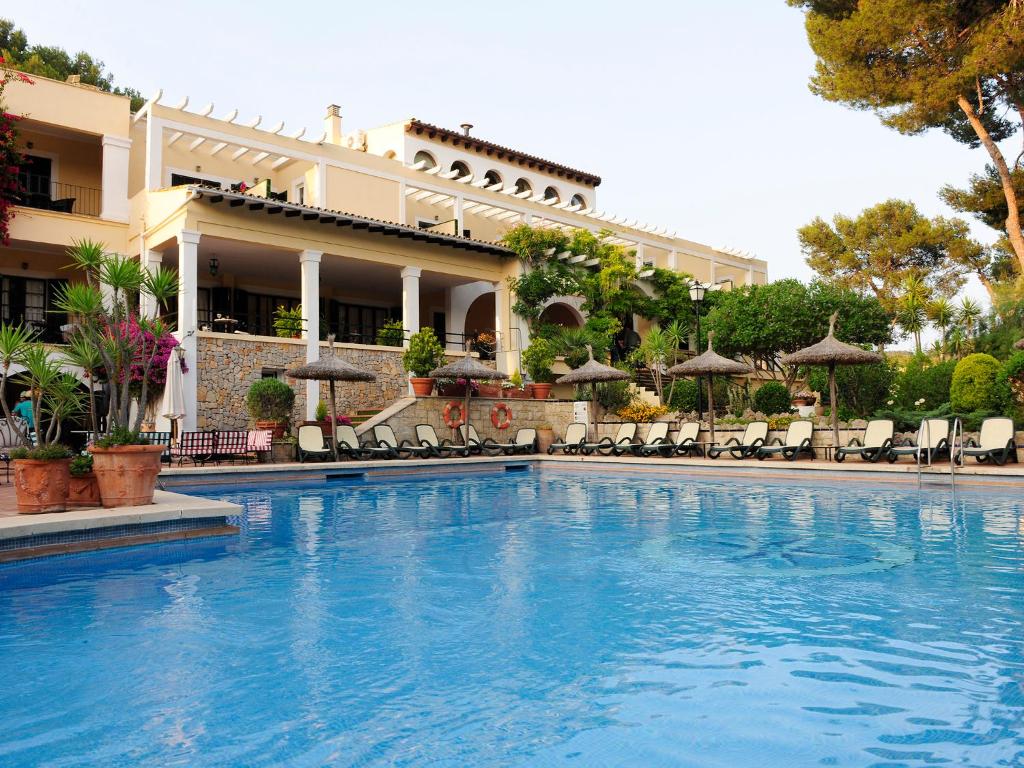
787,0 -> 1024,271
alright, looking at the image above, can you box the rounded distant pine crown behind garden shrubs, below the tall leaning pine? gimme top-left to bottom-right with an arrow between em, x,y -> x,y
798,200 -> 991,313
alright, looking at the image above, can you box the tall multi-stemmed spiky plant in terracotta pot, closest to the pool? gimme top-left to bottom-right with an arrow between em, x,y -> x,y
54,241 -> 178,507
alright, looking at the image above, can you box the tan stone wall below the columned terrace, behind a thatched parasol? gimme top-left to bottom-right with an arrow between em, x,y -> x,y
197,332 -> 407,429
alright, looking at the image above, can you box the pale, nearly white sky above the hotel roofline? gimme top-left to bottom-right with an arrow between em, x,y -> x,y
12,0 -> 1020,331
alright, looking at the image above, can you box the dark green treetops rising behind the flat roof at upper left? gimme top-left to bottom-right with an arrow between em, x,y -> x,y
0,18 -> 145,112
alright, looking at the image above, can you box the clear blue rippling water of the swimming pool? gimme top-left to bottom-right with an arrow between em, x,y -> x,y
0,470 -> 1024,768
